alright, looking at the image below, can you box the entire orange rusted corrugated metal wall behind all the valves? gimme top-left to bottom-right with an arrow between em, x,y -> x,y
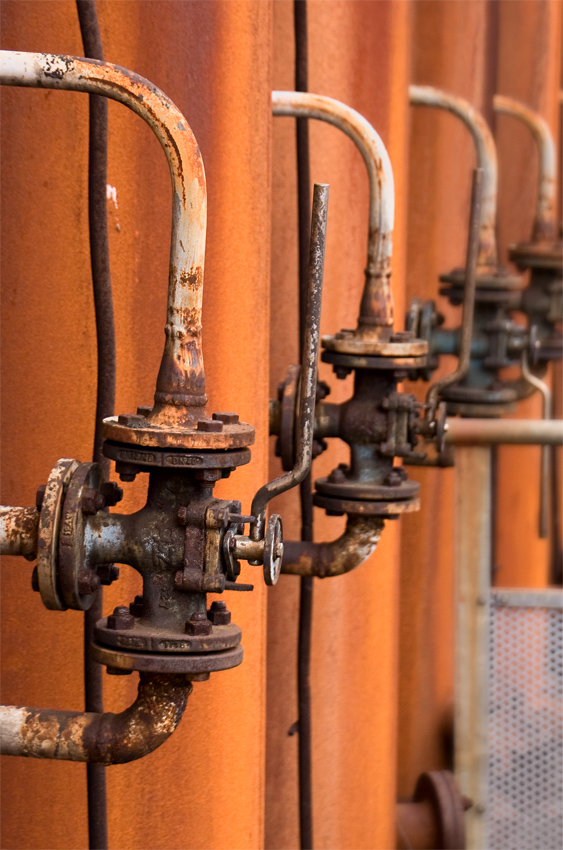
1,0 -> 561,850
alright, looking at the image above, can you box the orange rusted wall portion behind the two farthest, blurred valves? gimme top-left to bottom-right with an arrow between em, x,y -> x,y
398,0 -> 561,796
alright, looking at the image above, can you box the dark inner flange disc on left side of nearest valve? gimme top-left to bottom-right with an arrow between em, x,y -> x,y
59,463 -> 103,611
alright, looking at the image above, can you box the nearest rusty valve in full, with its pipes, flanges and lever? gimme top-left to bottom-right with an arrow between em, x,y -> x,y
0,52 -> 328,764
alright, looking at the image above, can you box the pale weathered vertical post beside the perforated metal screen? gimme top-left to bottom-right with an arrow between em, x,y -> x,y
454,446 -> 491,850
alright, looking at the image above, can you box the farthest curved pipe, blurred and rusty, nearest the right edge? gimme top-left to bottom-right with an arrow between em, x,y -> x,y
493,94 -> 557,242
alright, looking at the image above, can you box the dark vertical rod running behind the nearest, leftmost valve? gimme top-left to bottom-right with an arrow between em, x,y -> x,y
76,0 -> 115,850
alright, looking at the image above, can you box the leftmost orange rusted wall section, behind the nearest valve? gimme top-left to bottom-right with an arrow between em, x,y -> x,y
2,0 -> 272,850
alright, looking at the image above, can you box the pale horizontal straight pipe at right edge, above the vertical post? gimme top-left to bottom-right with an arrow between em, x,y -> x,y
445,416 -> 563,446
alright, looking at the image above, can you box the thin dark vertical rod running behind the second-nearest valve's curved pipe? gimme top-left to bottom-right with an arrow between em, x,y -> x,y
293,0 -> 313,850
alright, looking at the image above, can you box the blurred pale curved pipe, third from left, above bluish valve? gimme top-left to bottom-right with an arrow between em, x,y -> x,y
409,86 -> 498,267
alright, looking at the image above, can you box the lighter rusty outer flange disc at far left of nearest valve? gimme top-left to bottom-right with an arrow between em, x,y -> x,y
37,458 -> 78,611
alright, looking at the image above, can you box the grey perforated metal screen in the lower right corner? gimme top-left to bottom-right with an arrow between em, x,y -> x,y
486,591 -> 563,850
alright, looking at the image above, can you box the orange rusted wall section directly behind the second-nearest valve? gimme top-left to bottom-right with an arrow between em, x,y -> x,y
266,0 -> 411,850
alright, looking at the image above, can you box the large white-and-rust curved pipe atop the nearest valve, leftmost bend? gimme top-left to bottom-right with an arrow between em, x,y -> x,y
0,50 -> 207,427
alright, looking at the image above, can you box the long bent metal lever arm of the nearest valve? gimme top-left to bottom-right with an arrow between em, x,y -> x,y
250,183 -> 328,540
